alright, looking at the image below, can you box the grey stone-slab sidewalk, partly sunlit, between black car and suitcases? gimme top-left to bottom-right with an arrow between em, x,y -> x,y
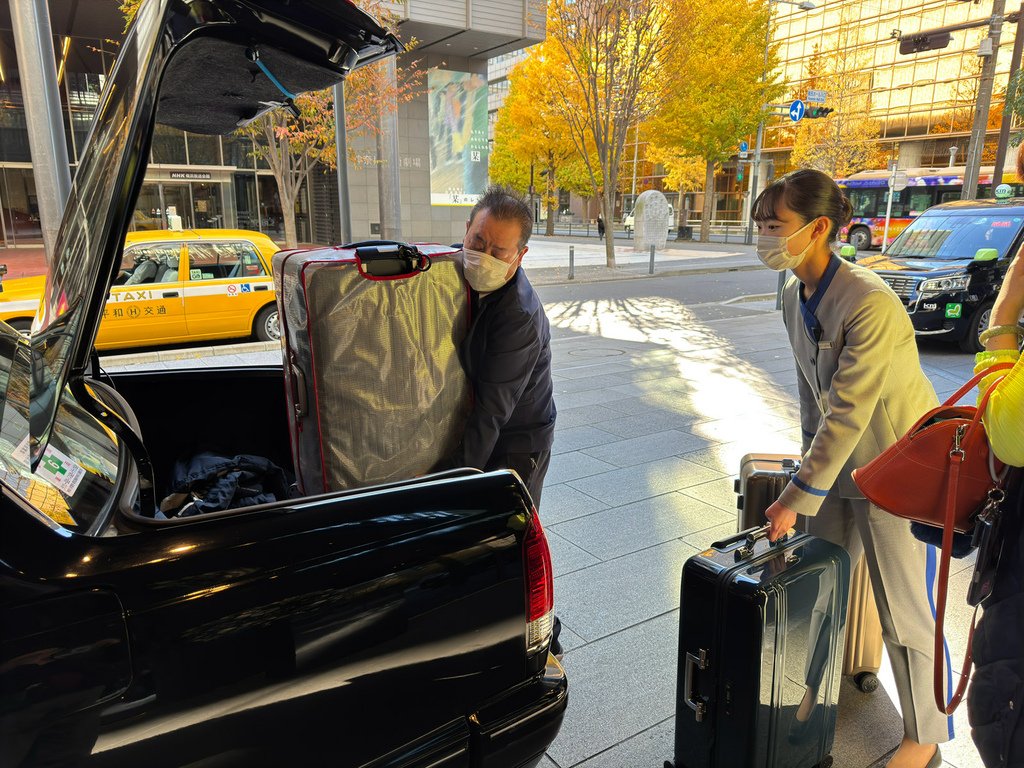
103,256 -> 981,768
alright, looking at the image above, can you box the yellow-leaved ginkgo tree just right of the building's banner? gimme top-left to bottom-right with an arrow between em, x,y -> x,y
489,39 -> 591,234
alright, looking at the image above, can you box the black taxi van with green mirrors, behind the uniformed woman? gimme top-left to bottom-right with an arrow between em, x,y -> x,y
857,198 -> 1024,352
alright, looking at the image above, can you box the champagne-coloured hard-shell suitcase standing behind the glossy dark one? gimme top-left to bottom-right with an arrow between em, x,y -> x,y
734,454 -> 885,693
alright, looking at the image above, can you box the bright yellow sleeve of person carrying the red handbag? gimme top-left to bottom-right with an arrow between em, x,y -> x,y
974,349 -> 1024,467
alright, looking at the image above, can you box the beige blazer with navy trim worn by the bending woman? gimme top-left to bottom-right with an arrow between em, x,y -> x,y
780,256 -> 938,515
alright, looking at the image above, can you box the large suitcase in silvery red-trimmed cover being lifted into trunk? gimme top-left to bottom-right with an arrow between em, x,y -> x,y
273,242 -> 471,495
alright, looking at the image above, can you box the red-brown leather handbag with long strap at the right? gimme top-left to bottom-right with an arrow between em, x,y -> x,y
853,362 -> 1014,715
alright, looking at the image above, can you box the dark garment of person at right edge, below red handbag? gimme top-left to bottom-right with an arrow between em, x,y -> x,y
966,470 -> 1024,768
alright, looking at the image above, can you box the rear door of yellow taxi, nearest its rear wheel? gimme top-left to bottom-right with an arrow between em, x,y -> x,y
185,240 -> 273,339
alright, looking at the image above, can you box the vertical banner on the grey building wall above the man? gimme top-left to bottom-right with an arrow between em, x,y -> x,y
427,70 -> 487,206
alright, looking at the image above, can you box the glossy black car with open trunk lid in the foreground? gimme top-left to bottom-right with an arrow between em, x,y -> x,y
0,0 -> 567,768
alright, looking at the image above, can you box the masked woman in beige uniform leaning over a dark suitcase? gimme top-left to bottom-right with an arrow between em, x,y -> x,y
753,170 -> 952,768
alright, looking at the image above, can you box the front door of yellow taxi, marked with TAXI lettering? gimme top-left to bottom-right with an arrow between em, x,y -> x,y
96,243 -> 185,349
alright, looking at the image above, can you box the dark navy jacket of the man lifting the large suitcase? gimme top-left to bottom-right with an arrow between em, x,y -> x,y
459,269 -> 555,469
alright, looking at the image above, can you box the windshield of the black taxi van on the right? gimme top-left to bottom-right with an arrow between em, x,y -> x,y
886,213 -> 1024,259
